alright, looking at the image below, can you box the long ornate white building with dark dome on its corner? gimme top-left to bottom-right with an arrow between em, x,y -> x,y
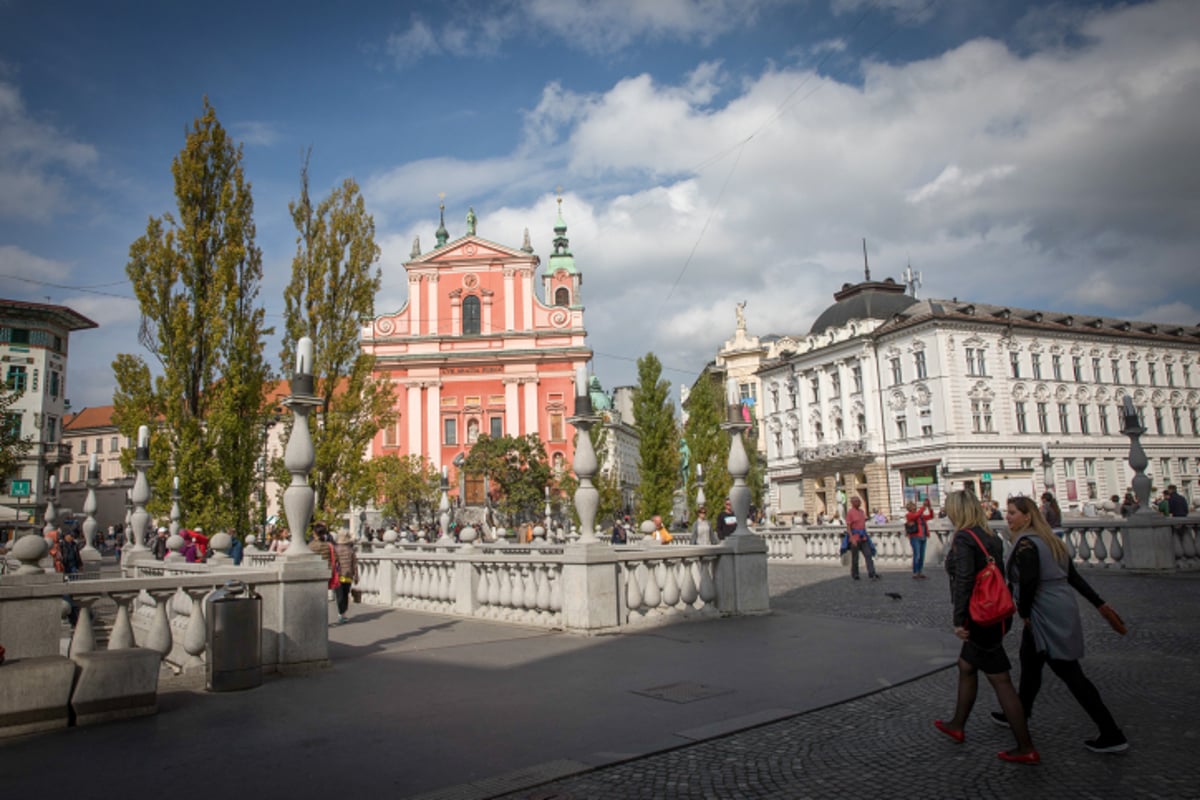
758,279 -> 1200,519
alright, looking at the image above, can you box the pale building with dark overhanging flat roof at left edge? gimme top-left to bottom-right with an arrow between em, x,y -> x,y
0,300 -> 97,522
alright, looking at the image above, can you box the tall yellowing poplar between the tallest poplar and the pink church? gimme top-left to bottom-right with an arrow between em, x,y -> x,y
281,158 -> 396,518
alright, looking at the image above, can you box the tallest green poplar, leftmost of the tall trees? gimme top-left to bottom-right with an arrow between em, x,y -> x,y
113,98 -> 271,534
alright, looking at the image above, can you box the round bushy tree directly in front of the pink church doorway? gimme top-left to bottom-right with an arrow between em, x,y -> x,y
462,433 -> 550,524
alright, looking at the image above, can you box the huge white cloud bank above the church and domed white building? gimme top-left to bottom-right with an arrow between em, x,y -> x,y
367,1 -> 1200,384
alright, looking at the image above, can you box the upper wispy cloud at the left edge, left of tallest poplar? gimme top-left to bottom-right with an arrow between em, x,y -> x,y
0,80 -> 97,222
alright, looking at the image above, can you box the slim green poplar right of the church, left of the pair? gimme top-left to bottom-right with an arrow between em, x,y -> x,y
634,353 -> 679,524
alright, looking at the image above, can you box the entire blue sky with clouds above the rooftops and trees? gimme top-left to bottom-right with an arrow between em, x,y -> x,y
0,0 -> 1200,410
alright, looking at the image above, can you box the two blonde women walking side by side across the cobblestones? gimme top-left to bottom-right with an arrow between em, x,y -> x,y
934,492 -> 1129,764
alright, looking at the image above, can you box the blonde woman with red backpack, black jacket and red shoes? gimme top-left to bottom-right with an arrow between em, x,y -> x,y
934,492 -> 1042,764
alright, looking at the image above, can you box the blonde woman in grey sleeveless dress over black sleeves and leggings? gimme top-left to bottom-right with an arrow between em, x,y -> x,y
991,498 -> 1129,753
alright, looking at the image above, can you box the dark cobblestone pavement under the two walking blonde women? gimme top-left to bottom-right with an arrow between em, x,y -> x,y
492,565 -> 1200,800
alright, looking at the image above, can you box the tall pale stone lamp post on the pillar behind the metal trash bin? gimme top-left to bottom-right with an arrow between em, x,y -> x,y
283,336 -> 320,559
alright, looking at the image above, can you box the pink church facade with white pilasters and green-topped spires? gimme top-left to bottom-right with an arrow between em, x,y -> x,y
360,201 -> 592,503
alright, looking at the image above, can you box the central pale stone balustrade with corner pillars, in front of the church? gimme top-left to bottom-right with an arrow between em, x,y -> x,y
355,536 -> 767,633
